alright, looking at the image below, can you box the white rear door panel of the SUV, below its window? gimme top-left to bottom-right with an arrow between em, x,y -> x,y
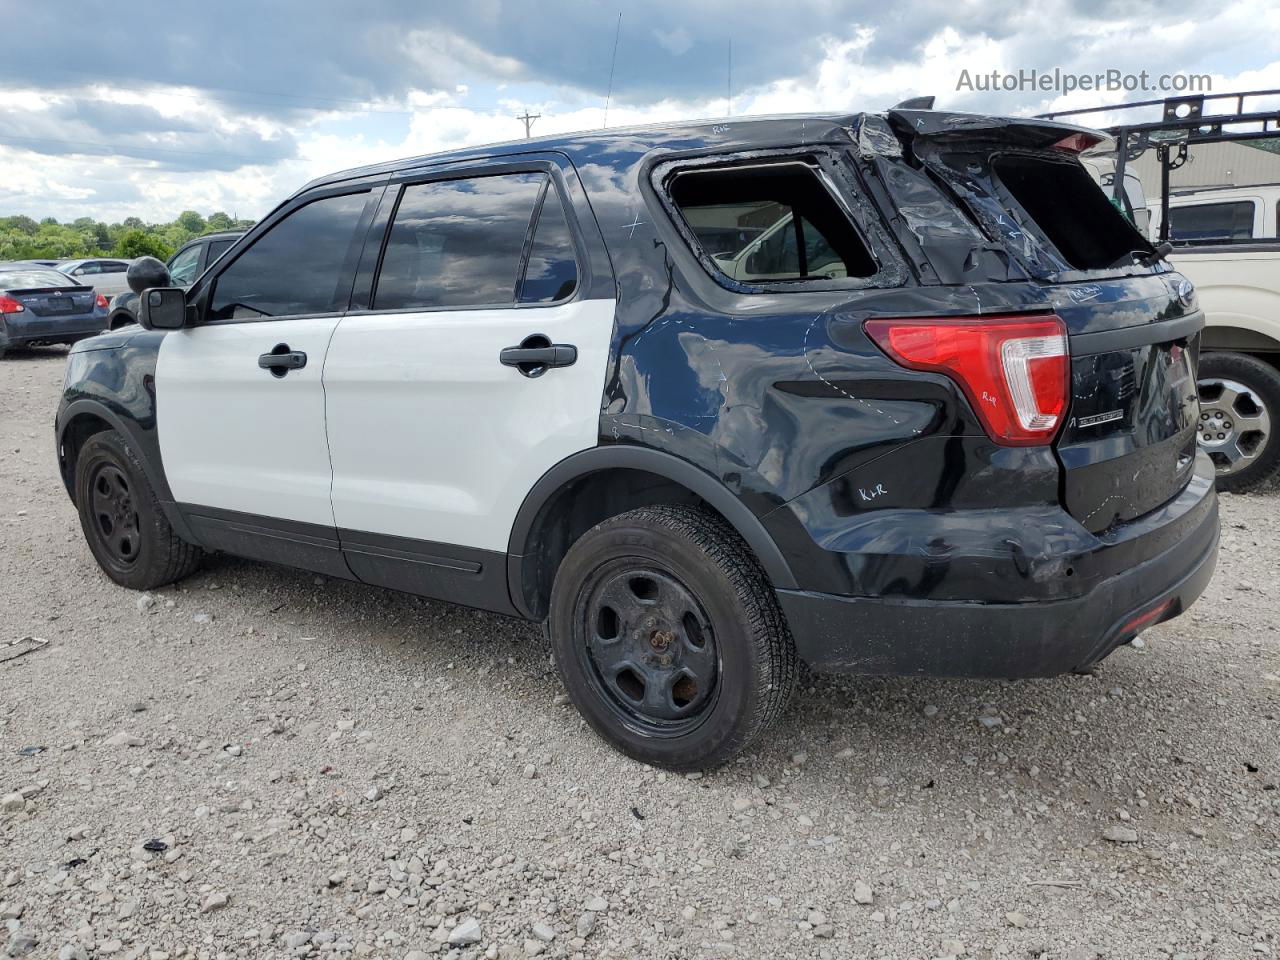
324,300 -> 614,552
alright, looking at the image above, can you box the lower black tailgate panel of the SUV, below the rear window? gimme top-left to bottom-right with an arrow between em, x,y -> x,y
1053,274 -> 1204,532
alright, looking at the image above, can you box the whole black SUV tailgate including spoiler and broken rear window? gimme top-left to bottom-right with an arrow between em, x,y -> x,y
890,110 -> 1204,532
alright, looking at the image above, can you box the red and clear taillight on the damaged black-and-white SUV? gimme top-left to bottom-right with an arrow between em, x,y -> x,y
867,316 -> 1069,447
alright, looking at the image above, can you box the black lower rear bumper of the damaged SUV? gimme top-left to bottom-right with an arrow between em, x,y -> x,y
778,454 -> 1219,677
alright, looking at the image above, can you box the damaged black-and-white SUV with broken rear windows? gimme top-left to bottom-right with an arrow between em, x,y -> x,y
56,106 -> 1217,769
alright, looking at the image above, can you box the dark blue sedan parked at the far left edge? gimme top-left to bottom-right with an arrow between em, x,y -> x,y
0,264 -> 108,357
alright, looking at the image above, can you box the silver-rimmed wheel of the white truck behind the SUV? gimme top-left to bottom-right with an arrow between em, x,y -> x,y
1198,352 -> 1280,493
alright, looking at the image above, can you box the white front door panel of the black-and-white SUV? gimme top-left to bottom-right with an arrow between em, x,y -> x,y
156,316 -> 338,526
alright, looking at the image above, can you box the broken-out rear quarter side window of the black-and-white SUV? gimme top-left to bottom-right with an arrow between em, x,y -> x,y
669,161 -> 877,283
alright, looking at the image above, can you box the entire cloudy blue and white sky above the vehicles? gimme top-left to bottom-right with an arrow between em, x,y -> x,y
0,0 -> 1280,220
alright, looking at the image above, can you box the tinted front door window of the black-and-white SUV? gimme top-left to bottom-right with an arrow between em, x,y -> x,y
210,192 -> 369,320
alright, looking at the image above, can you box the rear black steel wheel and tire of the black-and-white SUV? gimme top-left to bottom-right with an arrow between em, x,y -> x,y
547,506 -> 796,771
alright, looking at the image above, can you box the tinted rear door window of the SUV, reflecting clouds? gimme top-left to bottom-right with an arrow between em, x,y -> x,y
374,173 -> 547,310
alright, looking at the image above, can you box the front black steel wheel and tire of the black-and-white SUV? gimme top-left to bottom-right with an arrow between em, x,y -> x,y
76,430 -> 201,590
